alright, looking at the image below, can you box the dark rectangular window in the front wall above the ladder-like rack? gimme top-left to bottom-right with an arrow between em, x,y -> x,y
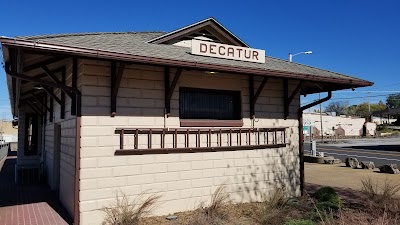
179,87 -> 242,120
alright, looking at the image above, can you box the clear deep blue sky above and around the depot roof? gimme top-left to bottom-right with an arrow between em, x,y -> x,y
0,0 -> 400,118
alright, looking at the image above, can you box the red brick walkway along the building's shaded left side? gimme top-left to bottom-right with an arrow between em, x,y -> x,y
0,156 -> 72,225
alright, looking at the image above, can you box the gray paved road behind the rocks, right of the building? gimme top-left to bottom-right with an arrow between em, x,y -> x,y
304,138 -> 400,166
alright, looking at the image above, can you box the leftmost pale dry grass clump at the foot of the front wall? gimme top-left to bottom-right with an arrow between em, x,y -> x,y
101,191 -> 161,225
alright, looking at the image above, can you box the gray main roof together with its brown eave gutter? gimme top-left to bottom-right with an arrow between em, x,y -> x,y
0,19 -> 373,94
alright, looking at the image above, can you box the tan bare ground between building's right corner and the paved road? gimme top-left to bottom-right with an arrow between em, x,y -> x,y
304,163 -> 400,195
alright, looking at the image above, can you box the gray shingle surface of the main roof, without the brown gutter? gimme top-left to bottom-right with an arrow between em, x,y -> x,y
10,32 -> 367,86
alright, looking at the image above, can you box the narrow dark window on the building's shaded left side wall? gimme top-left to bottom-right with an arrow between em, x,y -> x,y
24,114 -> 38,155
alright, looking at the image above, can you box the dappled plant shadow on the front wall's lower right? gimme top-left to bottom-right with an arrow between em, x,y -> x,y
228,120 -> 300,201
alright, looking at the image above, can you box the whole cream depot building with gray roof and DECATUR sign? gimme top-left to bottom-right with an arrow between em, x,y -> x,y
0,18 -> 372,224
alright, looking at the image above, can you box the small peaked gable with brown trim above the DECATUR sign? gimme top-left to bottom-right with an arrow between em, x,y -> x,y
148,17 -> 249,47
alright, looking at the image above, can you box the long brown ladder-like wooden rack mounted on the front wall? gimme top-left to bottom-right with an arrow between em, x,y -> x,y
115,127 -> 287,155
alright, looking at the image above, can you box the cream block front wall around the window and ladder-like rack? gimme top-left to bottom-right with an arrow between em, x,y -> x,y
80,60 -> 299,224
